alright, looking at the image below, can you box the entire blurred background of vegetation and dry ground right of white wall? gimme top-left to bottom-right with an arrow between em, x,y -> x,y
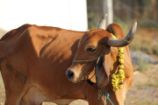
87,0 -> 158,105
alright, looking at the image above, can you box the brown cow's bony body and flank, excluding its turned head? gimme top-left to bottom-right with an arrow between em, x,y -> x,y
0,21 -> 136,105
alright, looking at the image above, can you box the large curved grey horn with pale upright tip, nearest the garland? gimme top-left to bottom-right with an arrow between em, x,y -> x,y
108,21 -> 137,47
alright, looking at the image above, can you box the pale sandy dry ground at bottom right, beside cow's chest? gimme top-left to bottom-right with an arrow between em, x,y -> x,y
126,65 -> 158,105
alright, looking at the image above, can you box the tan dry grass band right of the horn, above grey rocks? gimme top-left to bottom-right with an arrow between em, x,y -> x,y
130,28 -> 158,55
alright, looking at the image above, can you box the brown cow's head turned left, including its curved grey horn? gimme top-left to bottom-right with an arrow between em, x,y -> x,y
66,22 -> 137,83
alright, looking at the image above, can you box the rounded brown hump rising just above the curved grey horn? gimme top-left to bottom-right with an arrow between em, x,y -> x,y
106,23 -> 124,38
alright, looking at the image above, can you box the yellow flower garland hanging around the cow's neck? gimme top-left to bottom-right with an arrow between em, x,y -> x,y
112,35 -> 125,91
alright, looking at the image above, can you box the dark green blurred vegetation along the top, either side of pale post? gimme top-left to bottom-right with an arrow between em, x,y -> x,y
87,0 -> 158,28
